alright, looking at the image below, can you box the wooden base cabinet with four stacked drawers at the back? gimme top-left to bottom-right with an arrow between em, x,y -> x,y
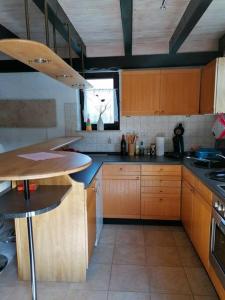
141,164 -> 181,220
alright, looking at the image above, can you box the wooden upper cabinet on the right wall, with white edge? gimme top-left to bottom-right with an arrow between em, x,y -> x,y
200,57 -> 225,114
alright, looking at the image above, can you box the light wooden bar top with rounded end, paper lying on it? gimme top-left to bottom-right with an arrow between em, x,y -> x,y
0,137 -> 92,180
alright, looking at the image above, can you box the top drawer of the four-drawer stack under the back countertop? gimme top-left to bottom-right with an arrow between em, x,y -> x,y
141,165 -> 181,176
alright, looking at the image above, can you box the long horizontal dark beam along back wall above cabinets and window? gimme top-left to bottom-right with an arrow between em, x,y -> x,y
0,52 -> 219,72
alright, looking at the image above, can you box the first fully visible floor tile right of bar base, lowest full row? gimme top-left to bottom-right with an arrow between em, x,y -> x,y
110,265 -> 149,292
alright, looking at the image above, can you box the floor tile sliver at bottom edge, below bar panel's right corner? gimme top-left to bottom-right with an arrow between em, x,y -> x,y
67,289 -> 108,300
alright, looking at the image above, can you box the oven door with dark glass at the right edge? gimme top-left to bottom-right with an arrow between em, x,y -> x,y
210,209 -> 225,287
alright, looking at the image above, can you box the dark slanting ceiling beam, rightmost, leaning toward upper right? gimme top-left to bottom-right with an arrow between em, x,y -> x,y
169,0 -> 213,53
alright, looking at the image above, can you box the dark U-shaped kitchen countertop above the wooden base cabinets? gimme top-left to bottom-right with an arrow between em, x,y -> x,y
70,153 -> 225,200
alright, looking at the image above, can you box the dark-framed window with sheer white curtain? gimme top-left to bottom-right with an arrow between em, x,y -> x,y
80,72 -> 120,130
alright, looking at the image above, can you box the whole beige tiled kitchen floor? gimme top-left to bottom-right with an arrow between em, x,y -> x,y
0,225 -> 218,300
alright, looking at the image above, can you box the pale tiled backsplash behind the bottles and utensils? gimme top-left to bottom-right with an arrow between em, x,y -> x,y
73,115 -> 215,152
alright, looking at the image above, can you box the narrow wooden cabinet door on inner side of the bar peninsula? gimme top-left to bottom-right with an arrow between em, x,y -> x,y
87,185 -> 96,261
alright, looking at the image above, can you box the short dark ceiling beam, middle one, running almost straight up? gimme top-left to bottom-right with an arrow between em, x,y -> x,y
120,0 -> 133,55
